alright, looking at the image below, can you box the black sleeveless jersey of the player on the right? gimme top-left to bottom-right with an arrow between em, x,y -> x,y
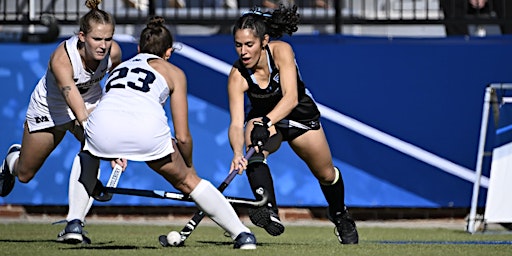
234,45 -> 320,126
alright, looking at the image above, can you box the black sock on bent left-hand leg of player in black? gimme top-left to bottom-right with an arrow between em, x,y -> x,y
246,162 -> 278,213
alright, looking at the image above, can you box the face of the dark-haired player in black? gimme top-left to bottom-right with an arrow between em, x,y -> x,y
235,28 -> 263,68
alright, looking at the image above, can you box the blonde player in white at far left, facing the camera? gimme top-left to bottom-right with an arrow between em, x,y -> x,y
0,0 -> 123,242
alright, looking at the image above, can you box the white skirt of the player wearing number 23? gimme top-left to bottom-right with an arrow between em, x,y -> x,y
84,109 -> 174,162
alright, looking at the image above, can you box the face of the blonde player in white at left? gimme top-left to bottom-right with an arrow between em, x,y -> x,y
80,24 -> 114,60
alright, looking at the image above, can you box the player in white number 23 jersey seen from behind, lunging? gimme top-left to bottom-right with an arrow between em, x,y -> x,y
67,17 -> 256,249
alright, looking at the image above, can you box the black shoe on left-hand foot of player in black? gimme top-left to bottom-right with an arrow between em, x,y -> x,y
249,206 -> 284,236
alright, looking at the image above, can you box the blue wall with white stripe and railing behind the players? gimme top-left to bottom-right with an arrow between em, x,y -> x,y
0,0 -> 512,226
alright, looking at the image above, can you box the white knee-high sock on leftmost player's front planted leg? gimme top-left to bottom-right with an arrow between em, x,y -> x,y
66,156 -> 99,222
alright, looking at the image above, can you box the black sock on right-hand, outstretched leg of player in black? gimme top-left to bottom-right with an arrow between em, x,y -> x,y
320,167 -> 345,216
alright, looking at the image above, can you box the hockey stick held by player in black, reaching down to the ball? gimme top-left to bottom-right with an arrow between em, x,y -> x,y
158,147 -> 258,247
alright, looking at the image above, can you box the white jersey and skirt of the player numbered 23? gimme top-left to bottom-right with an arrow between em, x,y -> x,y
84,53 -> 174,161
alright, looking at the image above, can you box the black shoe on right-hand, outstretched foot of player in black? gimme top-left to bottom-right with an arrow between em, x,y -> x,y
327,210 -> 359,244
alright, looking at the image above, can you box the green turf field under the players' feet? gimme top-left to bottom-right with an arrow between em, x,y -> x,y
0,223 -> 512,256
